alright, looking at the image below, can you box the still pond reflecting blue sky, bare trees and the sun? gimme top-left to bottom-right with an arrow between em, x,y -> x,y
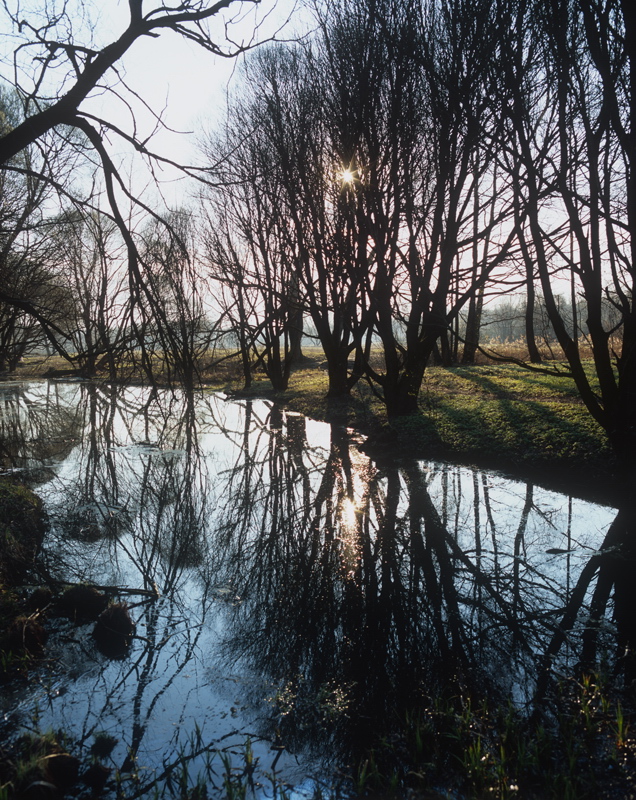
0,382 -> 633,798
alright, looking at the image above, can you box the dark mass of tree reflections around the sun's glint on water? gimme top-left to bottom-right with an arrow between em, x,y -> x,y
206,414 -> 605,761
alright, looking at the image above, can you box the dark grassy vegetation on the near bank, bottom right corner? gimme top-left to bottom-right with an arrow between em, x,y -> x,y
352,675 -> 636,800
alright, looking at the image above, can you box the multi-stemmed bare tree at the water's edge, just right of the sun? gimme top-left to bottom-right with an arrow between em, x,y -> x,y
322,0 -> 513,415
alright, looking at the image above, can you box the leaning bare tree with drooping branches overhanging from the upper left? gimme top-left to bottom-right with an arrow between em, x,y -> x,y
0,0 -> 286,384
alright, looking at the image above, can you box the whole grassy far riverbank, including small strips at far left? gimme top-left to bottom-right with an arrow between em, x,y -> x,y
9,351 -> 623,504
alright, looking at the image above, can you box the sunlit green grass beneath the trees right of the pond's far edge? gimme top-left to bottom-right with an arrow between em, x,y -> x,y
270,364 -> 614,494
